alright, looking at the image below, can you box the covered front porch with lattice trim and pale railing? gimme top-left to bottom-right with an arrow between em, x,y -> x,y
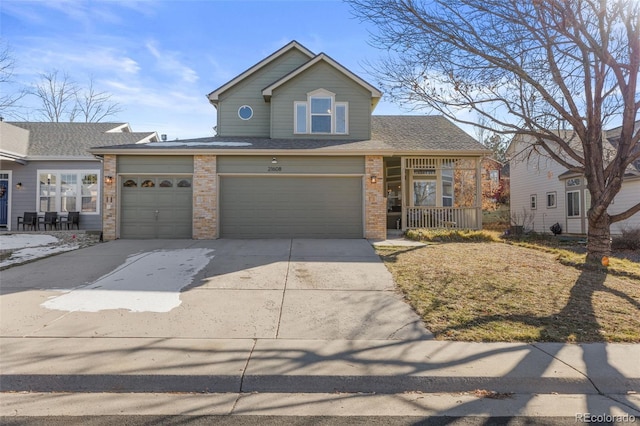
384,156 -> 482,231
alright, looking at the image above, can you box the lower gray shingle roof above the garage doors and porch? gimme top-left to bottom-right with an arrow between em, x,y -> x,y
90,115 -> 488,153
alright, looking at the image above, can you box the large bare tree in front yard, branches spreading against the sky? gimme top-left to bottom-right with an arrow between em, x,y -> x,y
346,0 -> 640,261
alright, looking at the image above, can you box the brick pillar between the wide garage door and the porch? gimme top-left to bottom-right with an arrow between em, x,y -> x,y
364,155 -> 387,240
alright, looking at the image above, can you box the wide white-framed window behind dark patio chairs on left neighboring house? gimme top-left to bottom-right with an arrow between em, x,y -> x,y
38,170 -> 100,213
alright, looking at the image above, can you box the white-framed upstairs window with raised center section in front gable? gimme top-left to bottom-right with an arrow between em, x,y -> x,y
293,89 -> 349,135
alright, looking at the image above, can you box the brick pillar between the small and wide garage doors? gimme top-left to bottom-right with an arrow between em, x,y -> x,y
192,155 -> 218,240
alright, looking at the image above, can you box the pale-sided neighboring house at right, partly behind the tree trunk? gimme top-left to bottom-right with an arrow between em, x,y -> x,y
507,128 -> 640,234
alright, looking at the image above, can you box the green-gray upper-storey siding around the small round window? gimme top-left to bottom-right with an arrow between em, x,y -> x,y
217,50 -> 309,137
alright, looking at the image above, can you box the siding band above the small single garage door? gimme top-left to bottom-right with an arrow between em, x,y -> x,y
117,155 -> 193,174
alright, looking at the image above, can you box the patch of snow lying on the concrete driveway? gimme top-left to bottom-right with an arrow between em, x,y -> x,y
41,249 -> 214,312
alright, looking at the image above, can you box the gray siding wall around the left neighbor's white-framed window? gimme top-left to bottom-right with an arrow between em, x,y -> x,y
0,161 -> 103,230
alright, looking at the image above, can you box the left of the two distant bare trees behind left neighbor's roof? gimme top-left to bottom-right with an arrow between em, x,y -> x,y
31,70 -> 78,123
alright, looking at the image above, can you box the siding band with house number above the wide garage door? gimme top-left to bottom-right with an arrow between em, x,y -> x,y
217,156 -> 365,175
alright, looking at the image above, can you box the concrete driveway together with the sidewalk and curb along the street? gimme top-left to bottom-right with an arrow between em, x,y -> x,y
0,240 -> 640,417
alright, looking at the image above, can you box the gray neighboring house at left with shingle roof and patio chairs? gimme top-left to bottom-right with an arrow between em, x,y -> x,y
0,121 -> 157,230
